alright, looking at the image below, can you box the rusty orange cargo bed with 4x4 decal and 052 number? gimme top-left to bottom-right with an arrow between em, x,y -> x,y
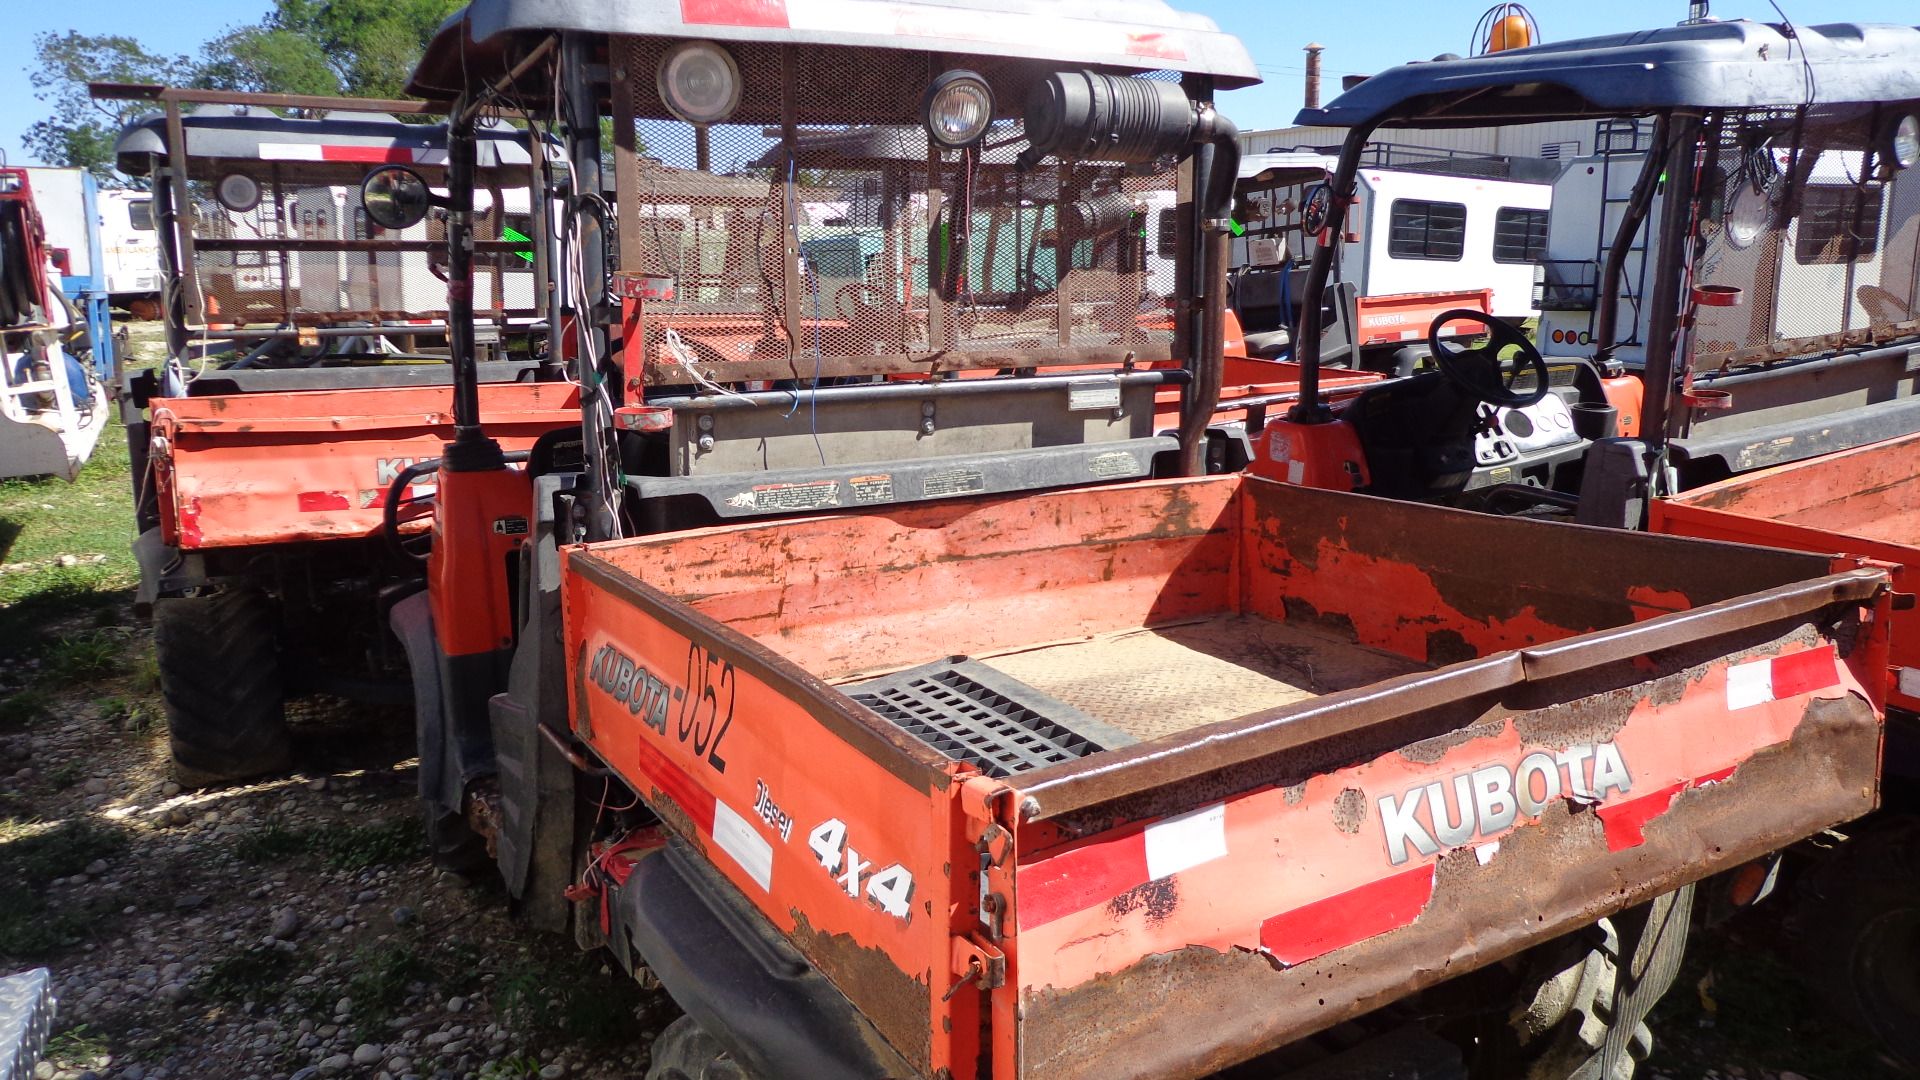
564,477 -> 1887,1078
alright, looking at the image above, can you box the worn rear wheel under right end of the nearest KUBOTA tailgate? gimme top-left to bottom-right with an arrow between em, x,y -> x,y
1469,886 -> 1693,1080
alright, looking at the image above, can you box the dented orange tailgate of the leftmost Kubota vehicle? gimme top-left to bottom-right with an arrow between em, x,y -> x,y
150,382 -> 580,550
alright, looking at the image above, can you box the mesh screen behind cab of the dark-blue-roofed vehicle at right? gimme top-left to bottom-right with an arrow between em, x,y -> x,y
1692,113 -> 1920,369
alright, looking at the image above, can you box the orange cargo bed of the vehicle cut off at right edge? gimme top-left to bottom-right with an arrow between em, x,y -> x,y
1647,424 -> 1920,711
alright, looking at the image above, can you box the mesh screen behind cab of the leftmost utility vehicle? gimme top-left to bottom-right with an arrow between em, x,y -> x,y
180,161 -> 538,327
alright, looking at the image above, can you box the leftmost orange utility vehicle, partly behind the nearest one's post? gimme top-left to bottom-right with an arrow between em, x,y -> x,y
94,85 -> 578,784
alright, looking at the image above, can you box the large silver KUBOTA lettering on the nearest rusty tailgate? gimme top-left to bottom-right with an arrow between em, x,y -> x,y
1379,742 -> 1634,867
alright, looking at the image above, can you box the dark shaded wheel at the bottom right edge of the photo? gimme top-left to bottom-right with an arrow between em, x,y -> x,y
1803,817 -> 1920,1068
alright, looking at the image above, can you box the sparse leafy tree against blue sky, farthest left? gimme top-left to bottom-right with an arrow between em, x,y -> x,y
23,31 -> 194,183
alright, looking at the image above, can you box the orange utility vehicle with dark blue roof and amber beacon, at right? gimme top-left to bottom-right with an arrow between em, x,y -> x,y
1254,21 -> 1920,1065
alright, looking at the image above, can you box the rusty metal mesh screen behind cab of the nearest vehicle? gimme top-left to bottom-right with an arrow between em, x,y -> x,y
614,38 -> 1175,384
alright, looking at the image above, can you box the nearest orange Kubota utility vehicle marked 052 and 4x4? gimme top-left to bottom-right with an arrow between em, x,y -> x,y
363,0 -> 1889,1078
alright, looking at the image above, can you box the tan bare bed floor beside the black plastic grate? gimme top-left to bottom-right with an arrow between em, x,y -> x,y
975,615 -> 1425,740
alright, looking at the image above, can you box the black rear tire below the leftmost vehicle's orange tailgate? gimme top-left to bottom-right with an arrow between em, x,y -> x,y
154,588 -> 292,788
